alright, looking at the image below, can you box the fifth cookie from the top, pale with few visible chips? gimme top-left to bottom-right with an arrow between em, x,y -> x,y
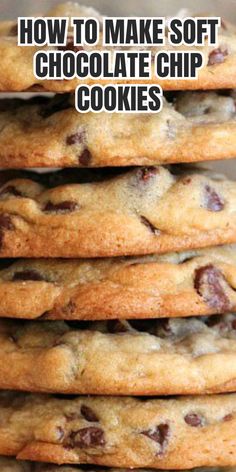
0,314 -> 236,396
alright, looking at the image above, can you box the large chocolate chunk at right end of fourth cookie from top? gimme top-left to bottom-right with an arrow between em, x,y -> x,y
194,264 -> 231,312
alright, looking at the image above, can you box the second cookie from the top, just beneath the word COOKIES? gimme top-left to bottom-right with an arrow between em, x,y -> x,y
0,92 -> 236,168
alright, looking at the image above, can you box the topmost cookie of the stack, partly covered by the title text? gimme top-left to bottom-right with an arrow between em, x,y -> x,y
0,2 -> 236,92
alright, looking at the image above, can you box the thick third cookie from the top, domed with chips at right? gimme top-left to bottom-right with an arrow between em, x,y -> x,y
0,167 -> 236,258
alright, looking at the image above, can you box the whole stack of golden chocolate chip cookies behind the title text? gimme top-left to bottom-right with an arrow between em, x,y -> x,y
0,3 -> 236,472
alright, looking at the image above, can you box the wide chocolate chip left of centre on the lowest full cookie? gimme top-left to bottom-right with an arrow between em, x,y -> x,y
64,426 -> 105,448
